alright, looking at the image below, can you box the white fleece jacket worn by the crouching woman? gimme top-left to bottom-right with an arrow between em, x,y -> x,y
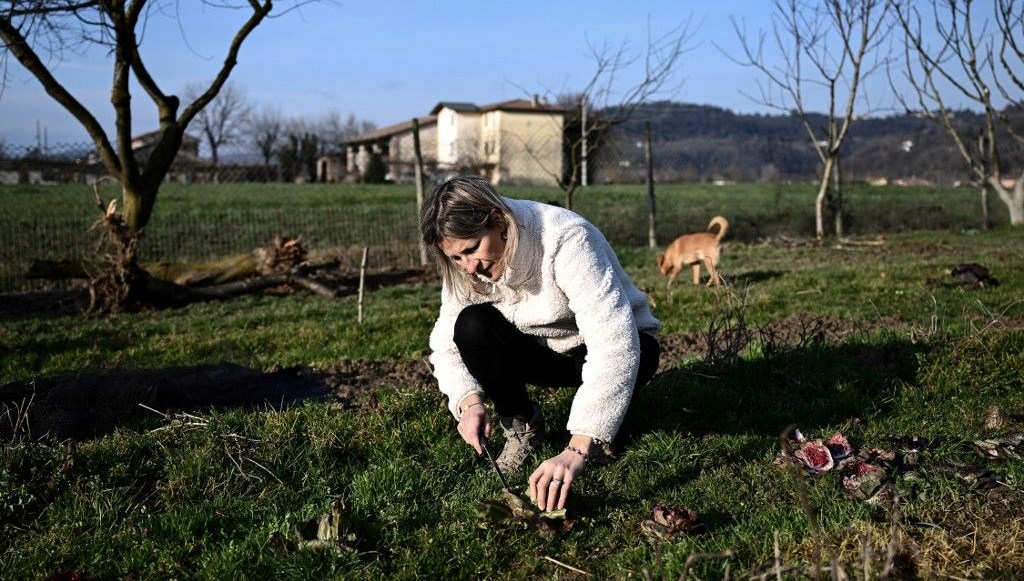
430,198 -> 660,441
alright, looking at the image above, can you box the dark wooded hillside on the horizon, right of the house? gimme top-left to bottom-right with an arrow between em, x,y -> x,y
592,101 -> 1024,183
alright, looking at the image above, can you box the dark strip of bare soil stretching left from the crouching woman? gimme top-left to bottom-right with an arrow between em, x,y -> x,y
0,360 -> 432,441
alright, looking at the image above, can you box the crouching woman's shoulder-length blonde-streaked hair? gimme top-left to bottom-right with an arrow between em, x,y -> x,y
420,175 -> 519,298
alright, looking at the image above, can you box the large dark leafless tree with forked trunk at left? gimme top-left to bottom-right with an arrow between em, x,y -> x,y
0,0 -> 302,302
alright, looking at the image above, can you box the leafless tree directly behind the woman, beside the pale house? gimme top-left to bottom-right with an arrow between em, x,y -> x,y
522,18 -> 692,208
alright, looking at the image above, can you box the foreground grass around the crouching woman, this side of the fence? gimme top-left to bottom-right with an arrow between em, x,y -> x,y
0,186 -> 1024,579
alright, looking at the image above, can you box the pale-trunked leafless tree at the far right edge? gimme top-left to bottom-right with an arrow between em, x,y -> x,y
890,0 -> 1024,227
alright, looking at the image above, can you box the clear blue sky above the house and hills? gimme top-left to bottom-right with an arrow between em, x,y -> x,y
0,0 -> 999,146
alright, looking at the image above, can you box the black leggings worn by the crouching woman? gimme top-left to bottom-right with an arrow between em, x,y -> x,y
455,303 -> 662,418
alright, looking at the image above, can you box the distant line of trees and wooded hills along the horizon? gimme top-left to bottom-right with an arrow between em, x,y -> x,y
8,101 -> 1024,185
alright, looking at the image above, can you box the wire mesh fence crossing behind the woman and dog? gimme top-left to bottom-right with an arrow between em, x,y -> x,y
0,136 -> 999,292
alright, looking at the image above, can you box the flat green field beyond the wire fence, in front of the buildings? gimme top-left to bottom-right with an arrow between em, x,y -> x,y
0,179 -> 1008,292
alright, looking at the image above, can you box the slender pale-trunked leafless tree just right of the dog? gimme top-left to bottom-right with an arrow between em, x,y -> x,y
732,0 -> 889,240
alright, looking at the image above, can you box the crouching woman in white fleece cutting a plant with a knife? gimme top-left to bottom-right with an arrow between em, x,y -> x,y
420,176 -> 660,510
